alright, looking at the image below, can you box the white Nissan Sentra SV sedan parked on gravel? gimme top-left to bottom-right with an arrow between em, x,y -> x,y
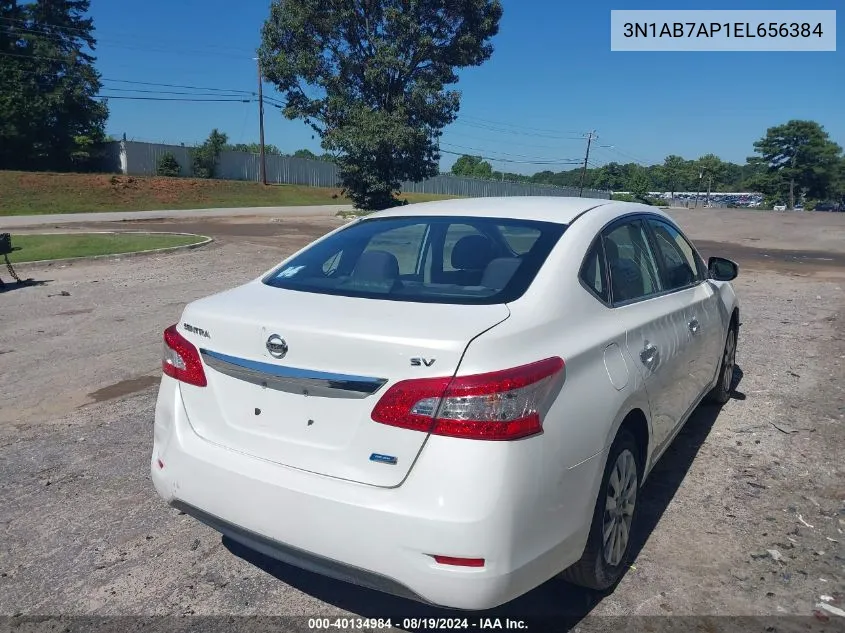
151,197 -> 740,609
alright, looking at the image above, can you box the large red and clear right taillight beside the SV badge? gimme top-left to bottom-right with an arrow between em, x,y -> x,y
372,357 -> 564,440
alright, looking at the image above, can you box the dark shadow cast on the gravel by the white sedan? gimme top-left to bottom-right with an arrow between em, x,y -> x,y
223,367 -> 745,631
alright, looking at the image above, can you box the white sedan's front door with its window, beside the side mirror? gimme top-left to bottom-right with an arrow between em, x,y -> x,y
648,218 -> 724,407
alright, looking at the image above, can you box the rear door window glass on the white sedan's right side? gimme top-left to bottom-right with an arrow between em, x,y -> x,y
604,220 -> 663,304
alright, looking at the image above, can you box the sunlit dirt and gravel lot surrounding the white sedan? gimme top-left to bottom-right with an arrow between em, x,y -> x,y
0,210 -> 845,631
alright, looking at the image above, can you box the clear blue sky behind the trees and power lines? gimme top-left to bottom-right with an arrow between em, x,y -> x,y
91,0 -> 845,173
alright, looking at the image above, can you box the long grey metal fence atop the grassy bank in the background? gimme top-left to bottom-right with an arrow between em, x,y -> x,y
105,141 -> 610,199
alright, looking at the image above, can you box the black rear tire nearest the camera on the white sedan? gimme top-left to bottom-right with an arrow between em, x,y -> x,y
560,428 -> 643,591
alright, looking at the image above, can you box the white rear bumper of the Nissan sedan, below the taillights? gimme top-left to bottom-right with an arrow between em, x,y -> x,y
151,377 -> 603,610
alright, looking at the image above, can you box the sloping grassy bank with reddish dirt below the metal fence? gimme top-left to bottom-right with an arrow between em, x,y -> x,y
0,171 -> 458,216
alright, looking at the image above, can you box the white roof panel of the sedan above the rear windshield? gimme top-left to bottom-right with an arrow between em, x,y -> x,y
367,196 -> 620,224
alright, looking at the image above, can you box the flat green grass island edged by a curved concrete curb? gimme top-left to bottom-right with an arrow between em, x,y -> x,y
9,233 -> 204,264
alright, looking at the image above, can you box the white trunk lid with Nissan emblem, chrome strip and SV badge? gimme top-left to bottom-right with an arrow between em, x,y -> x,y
179,282 -> 510,487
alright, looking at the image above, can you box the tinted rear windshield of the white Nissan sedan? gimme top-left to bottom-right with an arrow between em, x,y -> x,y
264,217 -> 566,304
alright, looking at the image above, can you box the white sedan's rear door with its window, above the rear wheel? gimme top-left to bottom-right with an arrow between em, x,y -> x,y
604,219 -> 690,447
